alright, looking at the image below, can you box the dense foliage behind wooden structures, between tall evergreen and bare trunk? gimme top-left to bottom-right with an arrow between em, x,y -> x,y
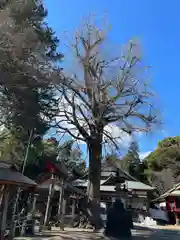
25,138 -> 86,180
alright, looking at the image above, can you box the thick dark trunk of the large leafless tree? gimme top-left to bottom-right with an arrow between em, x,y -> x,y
87,137 -> 102,229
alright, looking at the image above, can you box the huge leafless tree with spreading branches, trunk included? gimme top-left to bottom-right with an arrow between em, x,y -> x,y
55,19 -> 157,229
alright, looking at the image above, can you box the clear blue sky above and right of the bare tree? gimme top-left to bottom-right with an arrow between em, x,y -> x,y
45,0 -> 180,157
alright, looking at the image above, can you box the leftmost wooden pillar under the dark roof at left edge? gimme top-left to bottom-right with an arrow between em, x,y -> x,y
0,187 -> 9,240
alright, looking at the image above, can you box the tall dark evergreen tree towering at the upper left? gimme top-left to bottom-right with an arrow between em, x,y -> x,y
0,0 -> 62,153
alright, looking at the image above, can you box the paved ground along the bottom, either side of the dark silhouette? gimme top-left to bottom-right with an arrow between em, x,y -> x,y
16,227 -> 180,240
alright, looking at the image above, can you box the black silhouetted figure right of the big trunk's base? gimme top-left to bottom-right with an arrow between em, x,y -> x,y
104,200 -> 133,239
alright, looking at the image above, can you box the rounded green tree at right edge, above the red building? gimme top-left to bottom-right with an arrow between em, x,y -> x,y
144,136 -> 180,193
